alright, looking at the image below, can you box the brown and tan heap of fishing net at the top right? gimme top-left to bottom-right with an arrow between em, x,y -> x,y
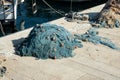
98,0 -> 120,28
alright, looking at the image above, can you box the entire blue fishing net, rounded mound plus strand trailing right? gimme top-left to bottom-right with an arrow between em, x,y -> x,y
16,23 -> 120,59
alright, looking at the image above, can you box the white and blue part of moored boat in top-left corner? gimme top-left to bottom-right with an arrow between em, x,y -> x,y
0,0 -> 17,21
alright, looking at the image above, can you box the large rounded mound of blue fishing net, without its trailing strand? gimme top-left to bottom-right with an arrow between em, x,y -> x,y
17,23 -> 82,59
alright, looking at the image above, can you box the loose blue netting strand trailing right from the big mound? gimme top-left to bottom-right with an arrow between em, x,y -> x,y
75,28 -> 120,50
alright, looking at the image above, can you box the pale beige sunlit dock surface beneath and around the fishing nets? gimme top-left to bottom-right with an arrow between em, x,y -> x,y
0,5 -> 120,80
